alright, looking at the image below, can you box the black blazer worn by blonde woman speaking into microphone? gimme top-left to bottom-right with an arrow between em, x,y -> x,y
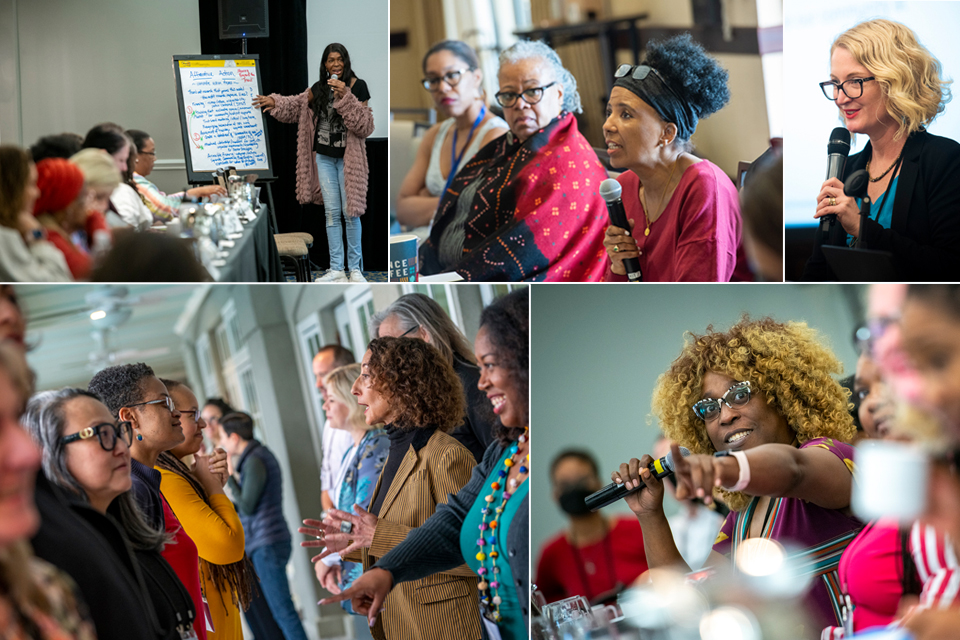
803,129 -> 960,282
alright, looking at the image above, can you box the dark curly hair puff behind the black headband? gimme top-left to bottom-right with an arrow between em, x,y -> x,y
644,33 -> 730,118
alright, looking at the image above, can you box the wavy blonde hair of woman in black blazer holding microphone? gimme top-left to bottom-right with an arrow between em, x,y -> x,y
830,19 -> 952,139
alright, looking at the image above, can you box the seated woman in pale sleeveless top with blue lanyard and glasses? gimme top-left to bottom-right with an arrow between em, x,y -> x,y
397,40 -> 507,235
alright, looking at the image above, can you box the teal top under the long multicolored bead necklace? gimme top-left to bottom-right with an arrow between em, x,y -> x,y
460,447 -> 530,640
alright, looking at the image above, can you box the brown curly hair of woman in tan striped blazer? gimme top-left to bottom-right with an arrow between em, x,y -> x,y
367,338 -> 466,432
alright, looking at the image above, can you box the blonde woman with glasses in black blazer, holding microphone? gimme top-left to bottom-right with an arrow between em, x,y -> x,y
804,20 -> 960,281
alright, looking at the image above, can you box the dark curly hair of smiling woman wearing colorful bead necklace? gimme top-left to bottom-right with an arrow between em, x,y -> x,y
480,287 -> 530,444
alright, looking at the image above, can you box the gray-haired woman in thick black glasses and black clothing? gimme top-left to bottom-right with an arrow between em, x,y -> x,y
22,388 -> 196,640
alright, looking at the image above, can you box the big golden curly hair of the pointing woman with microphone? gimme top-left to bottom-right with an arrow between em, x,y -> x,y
652,315 -> 856,511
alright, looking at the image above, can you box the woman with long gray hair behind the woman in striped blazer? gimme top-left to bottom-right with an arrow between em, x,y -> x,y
370,293 -> 496,462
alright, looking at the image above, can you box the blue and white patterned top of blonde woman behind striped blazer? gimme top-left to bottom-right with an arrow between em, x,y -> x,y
337,429 -> 390,613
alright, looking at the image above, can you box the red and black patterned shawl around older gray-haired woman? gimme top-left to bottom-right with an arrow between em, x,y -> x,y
420,113 -> 607,282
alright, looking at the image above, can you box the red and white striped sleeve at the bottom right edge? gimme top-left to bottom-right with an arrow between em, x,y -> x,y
910,522 -> 960,609
